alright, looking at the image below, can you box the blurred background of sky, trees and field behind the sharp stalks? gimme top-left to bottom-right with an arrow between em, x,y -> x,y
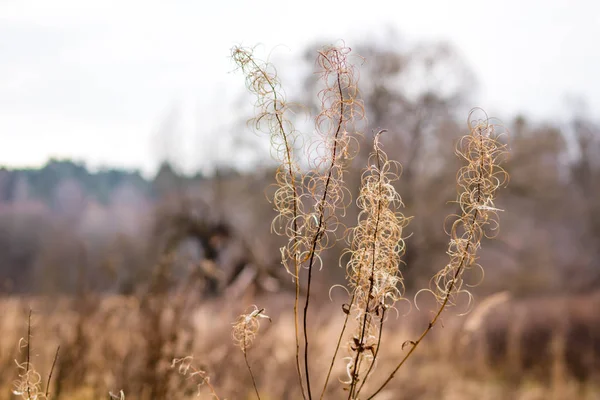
0,0 -> 600,399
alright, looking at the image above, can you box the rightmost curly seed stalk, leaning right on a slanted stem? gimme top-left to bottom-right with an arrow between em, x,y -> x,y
367,111 -> 508,399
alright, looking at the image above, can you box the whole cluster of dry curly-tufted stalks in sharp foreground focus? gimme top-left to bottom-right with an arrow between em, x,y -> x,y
227,45 -> 508,400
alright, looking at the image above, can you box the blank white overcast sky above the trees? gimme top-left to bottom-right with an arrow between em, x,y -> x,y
0,0 -> 600,172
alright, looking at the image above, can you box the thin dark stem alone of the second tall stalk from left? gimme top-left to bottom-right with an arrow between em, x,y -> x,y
303,73 -> 344,400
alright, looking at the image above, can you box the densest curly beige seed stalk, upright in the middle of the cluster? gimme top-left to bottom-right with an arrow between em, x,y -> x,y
346,131 -> 409,395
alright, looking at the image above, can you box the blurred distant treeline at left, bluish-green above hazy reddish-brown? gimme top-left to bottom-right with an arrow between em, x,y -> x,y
0,155 -> 263,293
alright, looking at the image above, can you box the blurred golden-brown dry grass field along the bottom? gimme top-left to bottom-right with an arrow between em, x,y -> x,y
0,295 -> 600,400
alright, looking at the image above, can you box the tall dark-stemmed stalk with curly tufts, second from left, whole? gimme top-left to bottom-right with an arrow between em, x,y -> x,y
302,46 -> 364,399
